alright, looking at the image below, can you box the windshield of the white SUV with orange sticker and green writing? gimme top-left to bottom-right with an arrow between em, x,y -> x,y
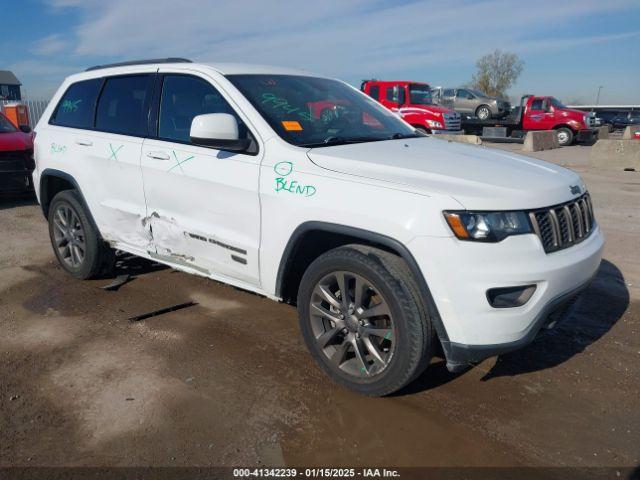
227,75 -> 421,147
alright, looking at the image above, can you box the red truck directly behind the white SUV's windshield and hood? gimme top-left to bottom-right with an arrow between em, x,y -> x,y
360,80 -> 460,133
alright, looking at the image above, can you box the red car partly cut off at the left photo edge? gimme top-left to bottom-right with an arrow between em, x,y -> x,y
0,112 -> 34,196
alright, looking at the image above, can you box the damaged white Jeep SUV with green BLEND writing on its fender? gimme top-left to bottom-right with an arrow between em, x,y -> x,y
34,59 -> 603,395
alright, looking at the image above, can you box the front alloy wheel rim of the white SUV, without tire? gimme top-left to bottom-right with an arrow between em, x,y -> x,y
309,271 -> 396,379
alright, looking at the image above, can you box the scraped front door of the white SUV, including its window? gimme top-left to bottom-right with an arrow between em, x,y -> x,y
141,73 -> 260,285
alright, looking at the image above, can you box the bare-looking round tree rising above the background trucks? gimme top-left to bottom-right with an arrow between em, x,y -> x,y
471,50 -> 524,98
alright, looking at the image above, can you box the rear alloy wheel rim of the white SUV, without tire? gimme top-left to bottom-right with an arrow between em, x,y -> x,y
53,204 -> 87,268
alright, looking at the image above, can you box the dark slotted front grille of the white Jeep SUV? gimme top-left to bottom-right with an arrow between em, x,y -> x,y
529,193 -> 595,253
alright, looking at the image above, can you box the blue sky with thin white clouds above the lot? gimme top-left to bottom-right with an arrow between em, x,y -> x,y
0,0 -> 640,104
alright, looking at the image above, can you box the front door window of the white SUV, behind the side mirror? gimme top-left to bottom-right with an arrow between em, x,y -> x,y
158,75 -> 247,142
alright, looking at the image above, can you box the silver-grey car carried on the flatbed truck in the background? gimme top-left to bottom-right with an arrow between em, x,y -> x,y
434,88 -> 511,120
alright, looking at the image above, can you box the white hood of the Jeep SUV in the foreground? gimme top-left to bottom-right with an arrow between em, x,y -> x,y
308,137 -> 584,210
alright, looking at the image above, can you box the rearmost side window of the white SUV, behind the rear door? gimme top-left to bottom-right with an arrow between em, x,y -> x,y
49,78 -> 102,129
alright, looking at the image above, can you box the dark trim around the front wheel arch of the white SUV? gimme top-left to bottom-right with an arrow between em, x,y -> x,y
276,221 -> 450,348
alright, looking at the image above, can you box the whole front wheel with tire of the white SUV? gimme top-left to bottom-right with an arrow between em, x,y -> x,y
298,245 -> 433,396
